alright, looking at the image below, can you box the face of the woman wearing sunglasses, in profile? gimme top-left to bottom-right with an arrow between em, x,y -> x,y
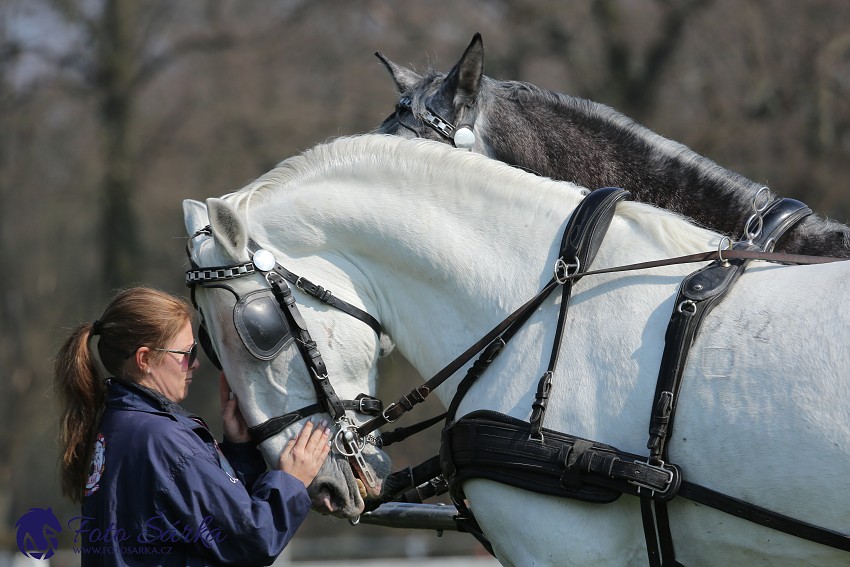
141,321 -> 201,404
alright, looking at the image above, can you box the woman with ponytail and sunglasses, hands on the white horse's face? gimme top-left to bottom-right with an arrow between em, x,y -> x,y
56,288 -> 330,566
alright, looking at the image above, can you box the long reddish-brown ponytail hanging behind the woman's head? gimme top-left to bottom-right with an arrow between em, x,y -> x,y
55,323 -> 106,502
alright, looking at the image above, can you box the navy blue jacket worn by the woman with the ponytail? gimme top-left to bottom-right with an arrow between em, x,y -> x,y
78,380 -> 310,567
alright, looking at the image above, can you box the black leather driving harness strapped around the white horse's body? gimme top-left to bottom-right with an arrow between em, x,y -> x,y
368,188 -> 850,567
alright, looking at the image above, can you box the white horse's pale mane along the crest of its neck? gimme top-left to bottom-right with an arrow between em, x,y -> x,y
225,134 -> 719,255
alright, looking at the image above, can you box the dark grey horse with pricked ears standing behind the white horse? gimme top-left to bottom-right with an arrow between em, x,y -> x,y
376,34 -> 850,258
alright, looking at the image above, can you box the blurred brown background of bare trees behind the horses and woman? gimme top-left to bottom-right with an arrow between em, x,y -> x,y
0,0 -> 850,560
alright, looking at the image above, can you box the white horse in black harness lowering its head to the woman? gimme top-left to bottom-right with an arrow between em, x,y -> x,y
184,136 -> 850,567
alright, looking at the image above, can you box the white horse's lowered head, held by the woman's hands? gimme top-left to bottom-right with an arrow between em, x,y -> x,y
184,197 -> 390,518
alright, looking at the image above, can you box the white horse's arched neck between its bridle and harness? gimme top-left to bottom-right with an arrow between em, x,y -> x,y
233,136 -> 710,440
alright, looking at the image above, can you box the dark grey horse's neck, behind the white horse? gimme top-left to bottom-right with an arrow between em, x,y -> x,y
476,78 -> 850,257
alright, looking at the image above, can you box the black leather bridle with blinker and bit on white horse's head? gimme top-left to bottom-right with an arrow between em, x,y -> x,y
186,226 -> 383,491
